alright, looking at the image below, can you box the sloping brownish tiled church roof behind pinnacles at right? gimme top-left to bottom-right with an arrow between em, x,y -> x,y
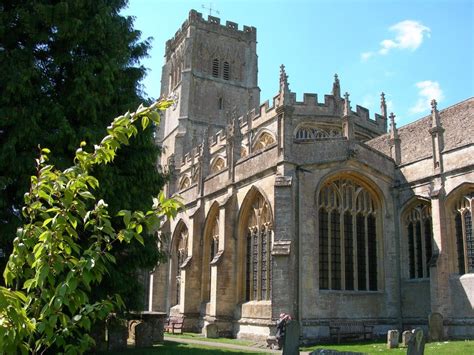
366,97 -> 474,164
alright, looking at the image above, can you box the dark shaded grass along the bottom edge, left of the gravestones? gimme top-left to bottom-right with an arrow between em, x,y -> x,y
99,341 -> 264,355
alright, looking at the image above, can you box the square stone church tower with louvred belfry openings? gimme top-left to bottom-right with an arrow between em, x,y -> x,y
158,10 -> 260,178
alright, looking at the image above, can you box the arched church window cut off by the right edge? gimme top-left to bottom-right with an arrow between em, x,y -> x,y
454,193 -> 474,275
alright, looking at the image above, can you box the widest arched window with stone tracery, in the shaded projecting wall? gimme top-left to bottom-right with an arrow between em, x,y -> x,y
319,179 -> 380,291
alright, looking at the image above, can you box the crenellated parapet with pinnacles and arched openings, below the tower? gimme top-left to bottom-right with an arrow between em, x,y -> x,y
171,71 -> 387,192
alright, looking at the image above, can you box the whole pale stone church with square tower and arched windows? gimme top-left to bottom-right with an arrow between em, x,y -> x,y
150,10 -> 474,339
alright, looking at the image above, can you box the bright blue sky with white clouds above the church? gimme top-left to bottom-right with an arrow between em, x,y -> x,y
123,0 -> 474,126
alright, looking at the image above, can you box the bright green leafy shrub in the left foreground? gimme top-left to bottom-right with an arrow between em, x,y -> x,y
0,101 -> 180,354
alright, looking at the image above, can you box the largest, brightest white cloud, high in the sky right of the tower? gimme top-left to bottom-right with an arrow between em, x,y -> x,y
360,20 -> 431,62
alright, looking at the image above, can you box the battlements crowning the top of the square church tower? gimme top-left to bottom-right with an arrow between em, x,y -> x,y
165,10 -> 257,57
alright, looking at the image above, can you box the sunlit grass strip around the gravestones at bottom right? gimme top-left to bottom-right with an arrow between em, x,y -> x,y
301,340 -> 474,355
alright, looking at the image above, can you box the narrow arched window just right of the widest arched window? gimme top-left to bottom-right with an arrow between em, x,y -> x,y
405,203 -> 433,279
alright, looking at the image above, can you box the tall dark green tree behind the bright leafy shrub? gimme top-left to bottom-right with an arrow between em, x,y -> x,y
0,0 -> 163,308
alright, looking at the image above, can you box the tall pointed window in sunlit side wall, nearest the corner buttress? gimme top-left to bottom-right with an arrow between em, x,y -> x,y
245,194 -> 272,301
